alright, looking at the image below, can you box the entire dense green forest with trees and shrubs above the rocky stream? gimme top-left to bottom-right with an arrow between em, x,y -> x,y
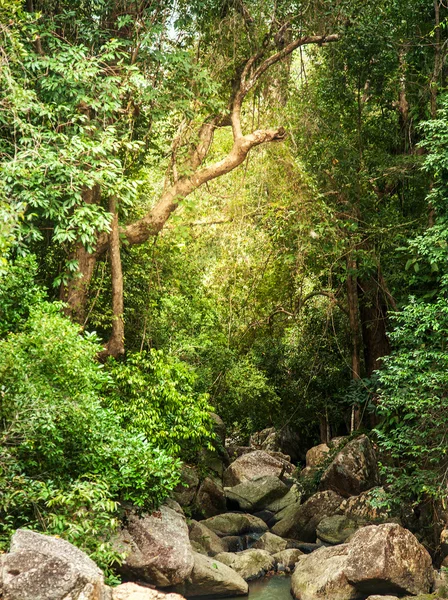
0,0 -> 448,568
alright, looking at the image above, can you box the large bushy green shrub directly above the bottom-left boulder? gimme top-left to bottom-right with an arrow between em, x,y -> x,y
0,302 -> 179,570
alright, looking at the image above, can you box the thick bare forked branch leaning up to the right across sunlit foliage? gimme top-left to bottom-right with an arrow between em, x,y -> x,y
95,34 -> 339,257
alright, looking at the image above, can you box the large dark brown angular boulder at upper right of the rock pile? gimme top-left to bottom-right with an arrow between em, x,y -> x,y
318,435 -> 379,498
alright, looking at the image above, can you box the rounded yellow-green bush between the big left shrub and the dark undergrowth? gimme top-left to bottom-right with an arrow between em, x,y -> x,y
107,350 -> 213,460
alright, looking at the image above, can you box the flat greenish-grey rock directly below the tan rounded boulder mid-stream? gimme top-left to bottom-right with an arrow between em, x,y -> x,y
224,475 -> 288,512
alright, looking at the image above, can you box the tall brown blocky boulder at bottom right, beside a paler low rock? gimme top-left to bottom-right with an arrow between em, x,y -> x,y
345,523 -> 434,595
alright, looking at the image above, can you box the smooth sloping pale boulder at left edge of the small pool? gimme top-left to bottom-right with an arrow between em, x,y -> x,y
176,553 -> 249,598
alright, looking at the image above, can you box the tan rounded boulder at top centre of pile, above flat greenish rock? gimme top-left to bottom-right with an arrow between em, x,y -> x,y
223,450 -> 285,487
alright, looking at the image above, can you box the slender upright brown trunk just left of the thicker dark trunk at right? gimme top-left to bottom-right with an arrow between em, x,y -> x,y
347,254 -> 361,432
